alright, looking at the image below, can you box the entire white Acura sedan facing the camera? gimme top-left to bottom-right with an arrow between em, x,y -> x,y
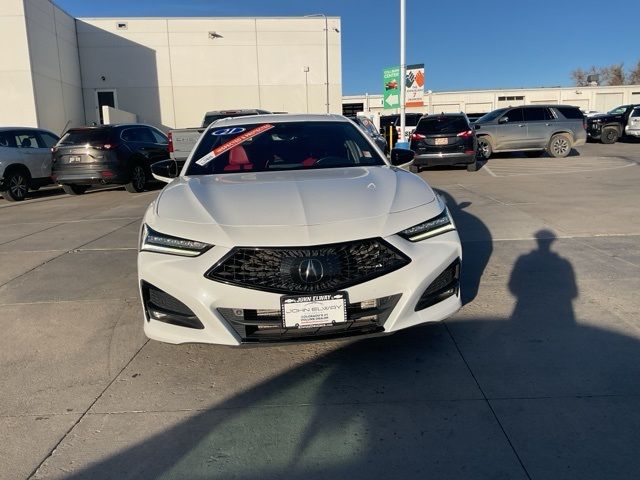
138,115 -> 462,345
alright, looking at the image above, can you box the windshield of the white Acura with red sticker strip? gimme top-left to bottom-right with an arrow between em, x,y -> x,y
186,122 -> 386,175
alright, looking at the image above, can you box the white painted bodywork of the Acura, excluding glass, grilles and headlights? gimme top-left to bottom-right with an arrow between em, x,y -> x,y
138,115 -> 462,345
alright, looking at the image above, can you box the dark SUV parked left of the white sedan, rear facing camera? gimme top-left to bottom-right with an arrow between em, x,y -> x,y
51,124 -> 169,195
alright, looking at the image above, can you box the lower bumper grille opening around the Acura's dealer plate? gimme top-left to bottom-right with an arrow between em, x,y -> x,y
218,294 -> 401,343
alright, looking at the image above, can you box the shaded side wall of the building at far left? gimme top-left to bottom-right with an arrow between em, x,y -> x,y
23,0 -> 85,135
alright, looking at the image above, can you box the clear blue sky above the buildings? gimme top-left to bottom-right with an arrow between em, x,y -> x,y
55,0 -> 640,95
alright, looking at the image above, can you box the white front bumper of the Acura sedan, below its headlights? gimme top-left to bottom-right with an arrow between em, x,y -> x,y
138,231 -> 462,345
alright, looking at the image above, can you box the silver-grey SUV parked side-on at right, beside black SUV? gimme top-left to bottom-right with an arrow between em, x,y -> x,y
474,105 -> 587,159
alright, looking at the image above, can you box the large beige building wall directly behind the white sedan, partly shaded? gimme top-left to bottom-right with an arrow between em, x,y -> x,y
76,17 -> 342,129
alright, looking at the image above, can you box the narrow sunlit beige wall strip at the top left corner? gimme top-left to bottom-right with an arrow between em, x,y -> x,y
0,0 -> 38,127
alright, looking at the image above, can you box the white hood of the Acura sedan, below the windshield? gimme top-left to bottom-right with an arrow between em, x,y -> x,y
151,166 -> 439,245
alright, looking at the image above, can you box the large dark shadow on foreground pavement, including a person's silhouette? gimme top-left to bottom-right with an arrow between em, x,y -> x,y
53,231 -> 640,480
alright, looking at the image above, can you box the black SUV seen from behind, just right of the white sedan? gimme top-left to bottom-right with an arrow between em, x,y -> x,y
409,113 -> 478,172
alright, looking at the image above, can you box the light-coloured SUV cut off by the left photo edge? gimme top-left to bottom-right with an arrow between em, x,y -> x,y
0,127 -> 59,202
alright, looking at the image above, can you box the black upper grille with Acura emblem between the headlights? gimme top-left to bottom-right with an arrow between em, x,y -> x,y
205,239 -> 411,294
